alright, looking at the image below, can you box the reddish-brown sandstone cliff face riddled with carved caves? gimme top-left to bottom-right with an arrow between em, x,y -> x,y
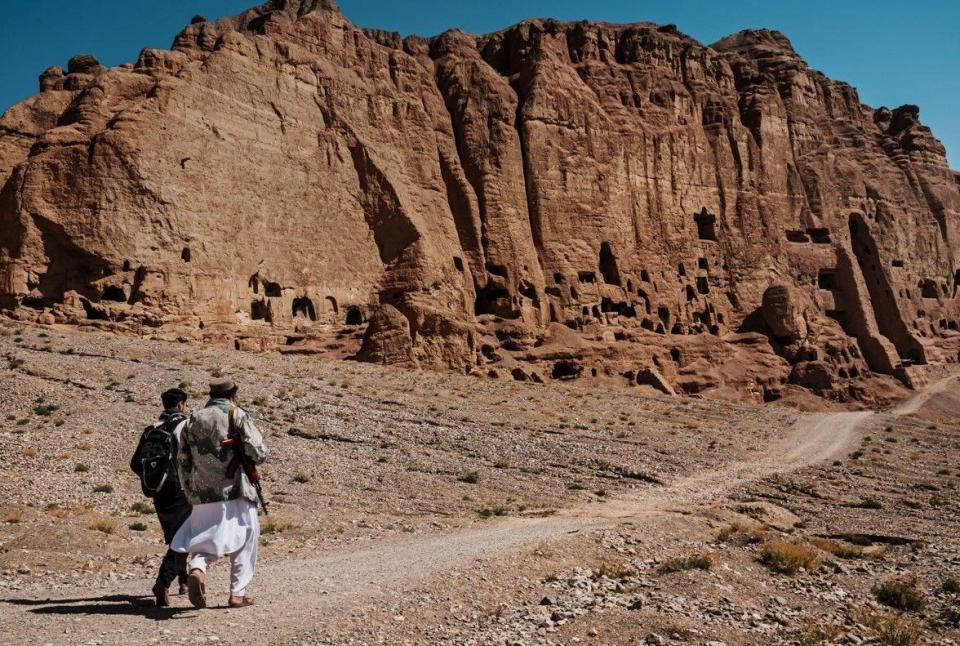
0,0 -> 960,400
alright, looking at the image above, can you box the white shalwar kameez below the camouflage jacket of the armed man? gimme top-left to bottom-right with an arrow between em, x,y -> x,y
170,498 -> 260,597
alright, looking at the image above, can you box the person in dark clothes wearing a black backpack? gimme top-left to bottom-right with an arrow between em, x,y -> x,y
130,388 -> 193,607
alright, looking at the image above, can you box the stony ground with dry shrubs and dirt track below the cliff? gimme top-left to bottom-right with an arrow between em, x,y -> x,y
0,322 -> 960,644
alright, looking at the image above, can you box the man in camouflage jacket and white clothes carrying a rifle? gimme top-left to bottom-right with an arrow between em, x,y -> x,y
172,380 -> 267,608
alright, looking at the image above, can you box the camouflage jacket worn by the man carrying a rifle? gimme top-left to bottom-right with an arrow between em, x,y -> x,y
177,399 -> 267,505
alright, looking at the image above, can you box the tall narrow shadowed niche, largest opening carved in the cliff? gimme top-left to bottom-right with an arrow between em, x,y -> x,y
849,213 -> 926,363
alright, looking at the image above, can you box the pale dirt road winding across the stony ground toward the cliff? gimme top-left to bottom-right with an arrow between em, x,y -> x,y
0,382 -> 946,644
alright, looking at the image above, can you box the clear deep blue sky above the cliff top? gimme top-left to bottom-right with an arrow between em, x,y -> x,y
0,0 -> 960,169
